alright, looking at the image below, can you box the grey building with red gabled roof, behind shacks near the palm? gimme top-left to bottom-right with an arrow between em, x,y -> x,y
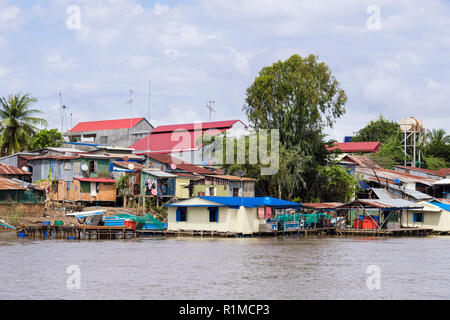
64,118 -> 154,147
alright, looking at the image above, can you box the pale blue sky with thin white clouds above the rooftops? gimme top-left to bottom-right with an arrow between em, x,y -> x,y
0,0 -> 450,141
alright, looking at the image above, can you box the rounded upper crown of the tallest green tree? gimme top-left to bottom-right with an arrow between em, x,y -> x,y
243,55 -> 347,151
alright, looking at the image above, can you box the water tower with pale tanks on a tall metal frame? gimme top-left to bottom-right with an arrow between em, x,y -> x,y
400,117 -> 425,167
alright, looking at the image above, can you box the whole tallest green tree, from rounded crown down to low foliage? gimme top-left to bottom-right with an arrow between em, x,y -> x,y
226,55 -> 347,201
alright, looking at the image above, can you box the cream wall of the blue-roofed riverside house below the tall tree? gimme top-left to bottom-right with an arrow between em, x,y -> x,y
168,207 -> 265,234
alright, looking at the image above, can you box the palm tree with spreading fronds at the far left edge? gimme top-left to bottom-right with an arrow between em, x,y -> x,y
0,93 -> 47,154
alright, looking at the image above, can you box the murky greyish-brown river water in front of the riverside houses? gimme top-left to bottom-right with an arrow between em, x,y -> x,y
0,233 -> 450,300
